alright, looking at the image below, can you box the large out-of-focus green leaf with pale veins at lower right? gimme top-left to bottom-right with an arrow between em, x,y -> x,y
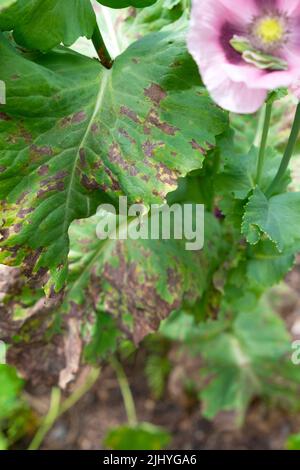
160,308 -> 300,424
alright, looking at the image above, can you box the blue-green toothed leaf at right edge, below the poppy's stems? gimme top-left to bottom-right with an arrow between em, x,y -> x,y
242,188 -> 300,252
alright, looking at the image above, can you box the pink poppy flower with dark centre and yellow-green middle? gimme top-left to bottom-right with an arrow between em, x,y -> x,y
188,0 -> 300,113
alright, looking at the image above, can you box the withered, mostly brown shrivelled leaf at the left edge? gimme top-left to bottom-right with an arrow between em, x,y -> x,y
0,265 -> 82,388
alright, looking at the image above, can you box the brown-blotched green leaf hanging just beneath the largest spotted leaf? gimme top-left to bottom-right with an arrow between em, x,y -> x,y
62,214 -> 222,343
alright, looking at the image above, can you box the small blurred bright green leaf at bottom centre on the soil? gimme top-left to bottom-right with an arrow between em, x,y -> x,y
104,423 -> 171,450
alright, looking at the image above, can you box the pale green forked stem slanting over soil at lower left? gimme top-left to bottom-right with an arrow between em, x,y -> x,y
28,368 -> 100,450
